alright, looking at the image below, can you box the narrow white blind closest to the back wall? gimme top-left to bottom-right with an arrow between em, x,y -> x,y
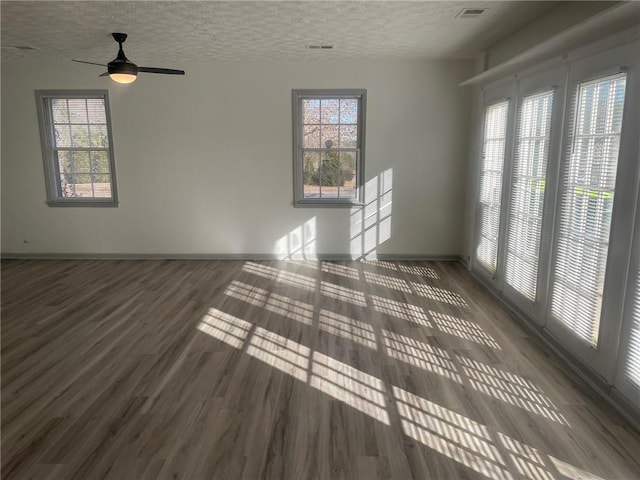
476,100 -> 509,273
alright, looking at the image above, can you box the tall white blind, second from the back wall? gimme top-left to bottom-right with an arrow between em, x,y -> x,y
505,90 -> 553,301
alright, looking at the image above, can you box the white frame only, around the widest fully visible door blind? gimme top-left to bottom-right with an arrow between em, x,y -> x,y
545,43 -> 639,383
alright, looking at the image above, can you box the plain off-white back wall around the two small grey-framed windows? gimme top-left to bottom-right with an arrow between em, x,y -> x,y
2,59 -> 473,257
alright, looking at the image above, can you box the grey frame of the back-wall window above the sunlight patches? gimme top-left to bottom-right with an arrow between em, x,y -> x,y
292,89 -> 367,207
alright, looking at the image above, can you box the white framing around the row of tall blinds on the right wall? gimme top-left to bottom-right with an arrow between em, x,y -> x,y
470,35 -> 640,386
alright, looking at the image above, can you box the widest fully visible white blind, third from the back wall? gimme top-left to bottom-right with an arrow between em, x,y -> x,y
551,73 -> 626,347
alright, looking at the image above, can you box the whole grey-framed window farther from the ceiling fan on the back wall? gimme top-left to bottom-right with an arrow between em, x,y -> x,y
293,90 -> 366,206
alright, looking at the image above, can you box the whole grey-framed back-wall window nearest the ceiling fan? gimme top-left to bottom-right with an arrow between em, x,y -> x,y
36,90 -> 118,206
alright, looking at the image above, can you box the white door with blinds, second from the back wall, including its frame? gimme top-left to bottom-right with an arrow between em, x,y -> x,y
503,68 -> 564,316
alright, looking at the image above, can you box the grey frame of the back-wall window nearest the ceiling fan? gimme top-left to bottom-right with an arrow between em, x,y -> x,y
35,90 -> 118,207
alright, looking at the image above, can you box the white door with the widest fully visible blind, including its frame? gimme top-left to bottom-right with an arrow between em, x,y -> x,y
547,44 -> 637,380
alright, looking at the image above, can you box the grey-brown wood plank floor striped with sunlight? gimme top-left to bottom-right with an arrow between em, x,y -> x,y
0,260 -> 640,480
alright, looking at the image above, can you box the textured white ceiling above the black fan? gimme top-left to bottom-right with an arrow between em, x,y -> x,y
1,1 -> 557,68
